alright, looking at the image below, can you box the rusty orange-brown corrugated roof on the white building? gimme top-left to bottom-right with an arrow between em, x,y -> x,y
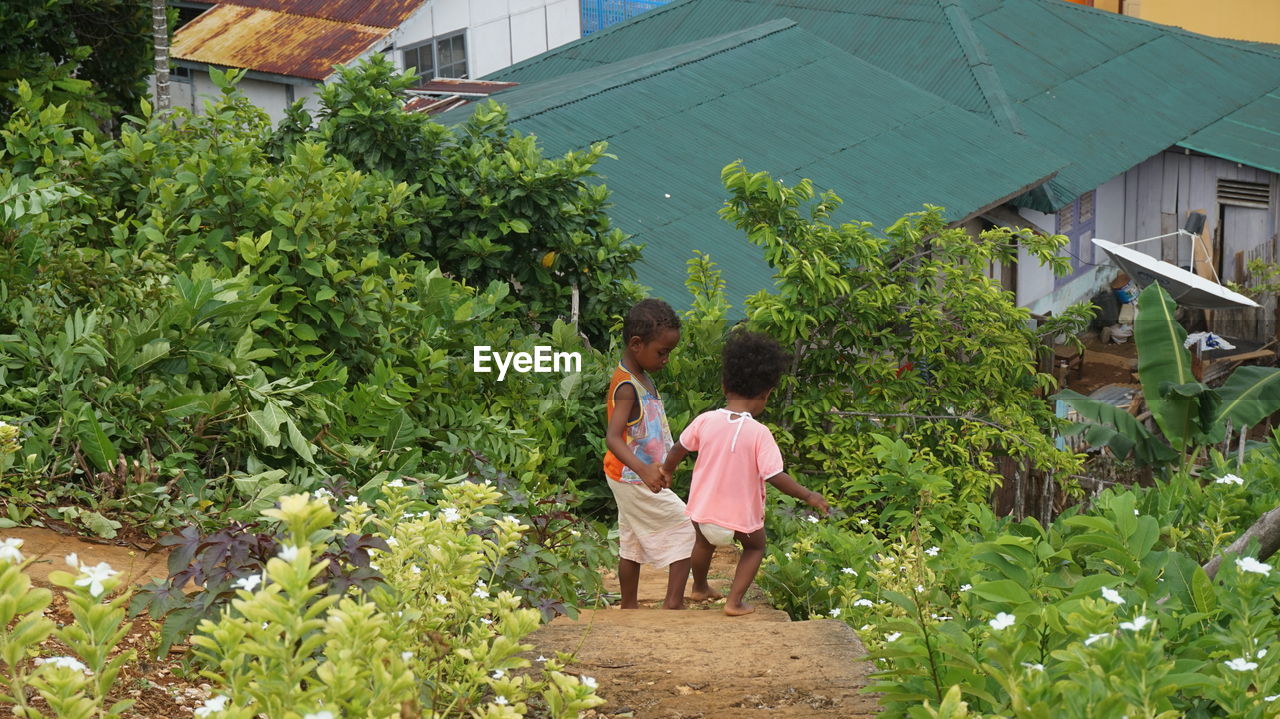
172,3 -> 390,81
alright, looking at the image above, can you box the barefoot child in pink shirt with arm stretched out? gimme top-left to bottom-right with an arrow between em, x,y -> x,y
662,331 -> 831,617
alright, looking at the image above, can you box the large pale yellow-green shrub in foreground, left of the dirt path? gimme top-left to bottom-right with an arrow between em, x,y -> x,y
192,482 -> 603,719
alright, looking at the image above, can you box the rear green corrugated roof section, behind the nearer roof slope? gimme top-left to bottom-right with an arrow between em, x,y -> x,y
490,0 -> 1280,211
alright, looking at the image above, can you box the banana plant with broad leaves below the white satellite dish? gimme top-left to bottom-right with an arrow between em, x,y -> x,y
1055,284 -> 1280,467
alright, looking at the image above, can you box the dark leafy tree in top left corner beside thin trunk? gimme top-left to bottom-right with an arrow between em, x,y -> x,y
0,0 -> 152,128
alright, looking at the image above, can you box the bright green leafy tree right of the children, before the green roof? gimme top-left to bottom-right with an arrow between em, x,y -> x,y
721,162 -> 1088,526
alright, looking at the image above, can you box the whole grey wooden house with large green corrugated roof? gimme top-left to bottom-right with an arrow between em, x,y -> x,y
442,0 -> 1280,335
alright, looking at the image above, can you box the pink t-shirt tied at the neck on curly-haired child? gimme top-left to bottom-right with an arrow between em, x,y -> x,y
680,409 -> 782,532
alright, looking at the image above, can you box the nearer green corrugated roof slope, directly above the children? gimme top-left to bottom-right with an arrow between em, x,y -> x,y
440,20 -> 1062,308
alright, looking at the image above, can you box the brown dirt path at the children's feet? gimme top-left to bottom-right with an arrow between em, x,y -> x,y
529,550 -> 878,719
